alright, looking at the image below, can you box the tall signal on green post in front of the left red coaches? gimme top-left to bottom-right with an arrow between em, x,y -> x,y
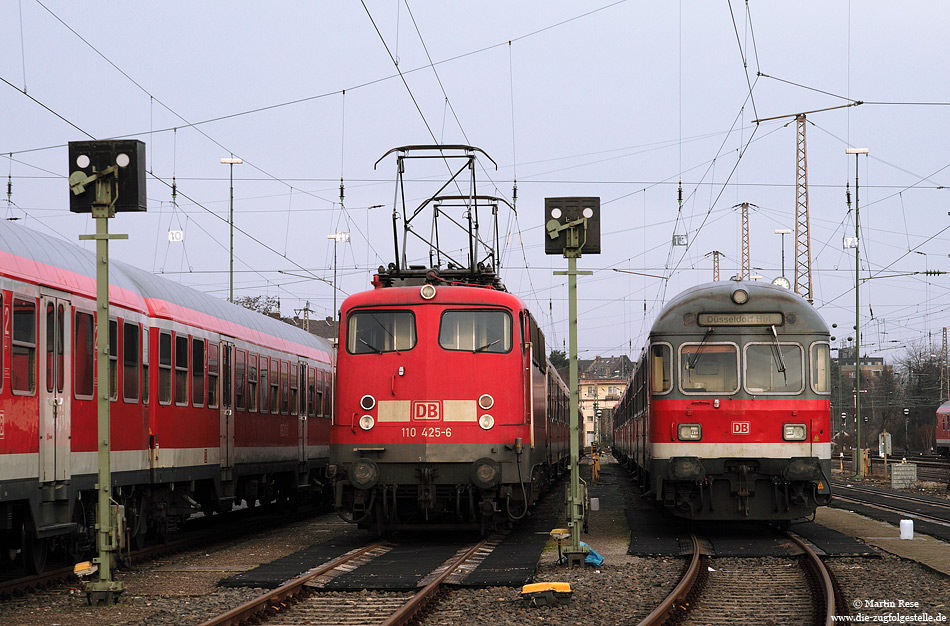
69,140 -> 146,605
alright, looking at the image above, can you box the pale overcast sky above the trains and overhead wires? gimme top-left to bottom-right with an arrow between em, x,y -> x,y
0,0 -> 950,358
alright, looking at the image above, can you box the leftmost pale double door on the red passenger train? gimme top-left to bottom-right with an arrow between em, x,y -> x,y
38,291 -> 72,482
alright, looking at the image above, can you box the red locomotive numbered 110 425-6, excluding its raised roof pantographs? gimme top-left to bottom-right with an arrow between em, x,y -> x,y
330,271 -> 569,532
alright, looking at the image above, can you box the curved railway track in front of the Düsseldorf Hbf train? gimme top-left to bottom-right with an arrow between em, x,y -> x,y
640,534 -> 847,626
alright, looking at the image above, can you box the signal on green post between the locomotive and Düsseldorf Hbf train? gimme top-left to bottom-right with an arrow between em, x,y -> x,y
544,197 -> 600,566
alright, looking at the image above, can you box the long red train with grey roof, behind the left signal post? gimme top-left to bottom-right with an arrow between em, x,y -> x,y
0,221 -> 332,570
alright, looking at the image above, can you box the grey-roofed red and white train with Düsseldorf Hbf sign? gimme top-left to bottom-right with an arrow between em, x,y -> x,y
614,281 -> 831,525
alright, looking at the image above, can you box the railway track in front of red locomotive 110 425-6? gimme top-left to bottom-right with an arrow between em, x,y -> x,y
195,538 -> 492,626
